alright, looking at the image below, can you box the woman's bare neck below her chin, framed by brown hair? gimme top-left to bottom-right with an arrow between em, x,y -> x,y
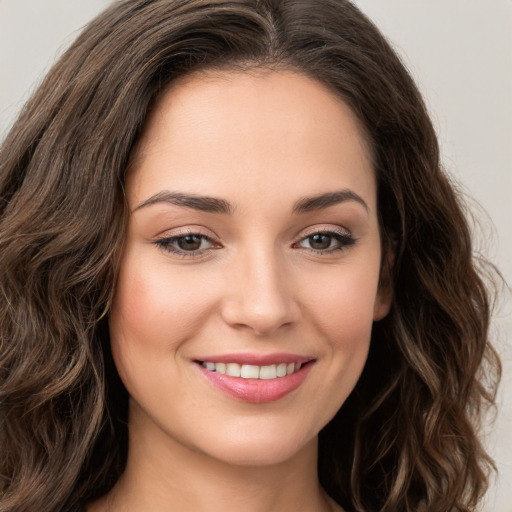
92,402 -> 336,512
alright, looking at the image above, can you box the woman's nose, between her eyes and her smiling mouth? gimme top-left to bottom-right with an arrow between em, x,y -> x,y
222,250 -> 300,336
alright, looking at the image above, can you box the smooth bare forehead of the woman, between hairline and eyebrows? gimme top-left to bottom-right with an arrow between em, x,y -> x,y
127,71 -> 375,212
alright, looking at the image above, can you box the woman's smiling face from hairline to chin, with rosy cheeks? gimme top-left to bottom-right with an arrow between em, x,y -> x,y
110,71 -> 389,465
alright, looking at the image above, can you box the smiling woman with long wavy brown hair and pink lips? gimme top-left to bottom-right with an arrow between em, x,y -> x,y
0,0 -> 499,512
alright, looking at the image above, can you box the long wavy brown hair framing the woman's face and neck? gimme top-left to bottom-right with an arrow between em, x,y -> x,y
0,0 -> 499,512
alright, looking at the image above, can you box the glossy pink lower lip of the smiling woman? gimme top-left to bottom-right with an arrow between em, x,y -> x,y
196,361 -> 313,404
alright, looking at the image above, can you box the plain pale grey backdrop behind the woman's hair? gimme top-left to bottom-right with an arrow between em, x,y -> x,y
0,0 -> 512,512
